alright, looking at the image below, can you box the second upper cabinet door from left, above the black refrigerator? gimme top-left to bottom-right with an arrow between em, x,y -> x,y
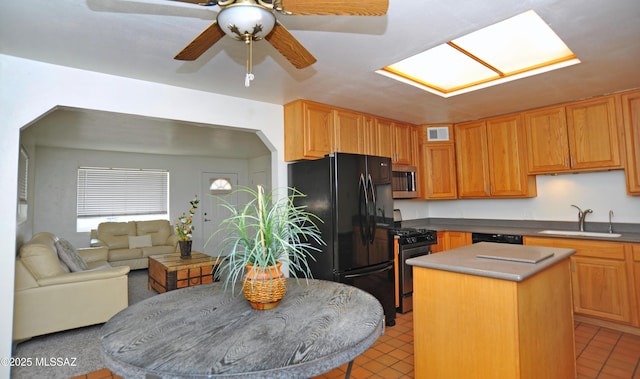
333,110 -> 364,154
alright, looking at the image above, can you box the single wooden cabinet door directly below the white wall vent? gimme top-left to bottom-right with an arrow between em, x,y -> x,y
419,143 -> 458,199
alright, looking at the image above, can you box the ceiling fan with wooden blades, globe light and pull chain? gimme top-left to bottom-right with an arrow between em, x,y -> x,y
173,0 -> 389,87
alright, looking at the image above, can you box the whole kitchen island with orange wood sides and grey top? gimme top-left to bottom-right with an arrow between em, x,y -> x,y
407,242 -> 576,379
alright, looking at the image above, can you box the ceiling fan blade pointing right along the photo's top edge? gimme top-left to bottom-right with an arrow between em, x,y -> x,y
280,0 -> 389,16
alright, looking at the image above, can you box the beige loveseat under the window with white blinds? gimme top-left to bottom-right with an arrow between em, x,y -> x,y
91,220 -> 178,270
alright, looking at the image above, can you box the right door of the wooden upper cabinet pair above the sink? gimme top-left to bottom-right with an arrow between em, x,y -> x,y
566,96 -> 622,170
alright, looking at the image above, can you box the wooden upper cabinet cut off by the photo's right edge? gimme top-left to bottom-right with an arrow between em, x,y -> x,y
622,91 -> 640,194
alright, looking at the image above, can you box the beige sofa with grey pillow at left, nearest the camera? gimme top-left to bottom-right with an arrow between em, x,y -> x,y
13,232 -> 129,342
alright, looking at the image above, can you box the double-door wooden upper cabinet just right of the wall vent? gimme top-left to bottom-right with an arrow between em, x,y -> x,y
455,114 -> 536,198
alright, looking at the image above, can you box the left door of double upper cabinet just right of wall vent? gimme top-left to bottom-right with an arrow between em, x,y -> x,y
454,121 -> 490,198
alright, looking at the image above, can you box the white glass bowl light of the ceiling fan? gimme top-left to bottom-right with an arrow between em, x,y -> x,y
217,2 -> 276,41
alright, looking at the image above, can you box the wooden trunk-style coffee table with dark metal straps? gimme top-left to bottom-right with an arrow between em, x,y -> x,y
149,251 -> 224,293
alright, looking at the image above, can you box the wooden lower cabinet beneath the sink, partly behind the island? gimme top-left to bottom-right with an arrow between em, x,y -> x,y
524,237 -> 637,324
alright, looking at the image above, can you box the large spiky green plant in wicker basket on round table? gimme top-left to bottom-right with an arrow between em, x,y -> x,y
209,186 -> 325,309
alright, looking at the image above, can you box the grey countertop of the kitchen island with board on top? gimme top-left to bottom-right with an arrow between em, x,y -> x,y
407,242 -> 575,282
